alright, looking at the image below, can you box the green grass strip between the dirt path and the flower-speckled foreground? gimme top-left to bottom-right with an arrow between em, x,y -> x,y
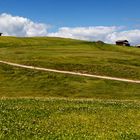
0,64 -> 140,100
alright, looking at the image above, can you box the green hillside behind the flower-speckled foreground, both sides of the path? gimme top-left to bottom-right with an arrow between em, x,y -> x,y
0,37 -> 140,99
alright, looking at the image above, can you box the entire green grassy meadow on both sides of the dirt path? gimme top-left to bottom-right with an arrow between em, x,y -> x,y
0,37 -> 140,140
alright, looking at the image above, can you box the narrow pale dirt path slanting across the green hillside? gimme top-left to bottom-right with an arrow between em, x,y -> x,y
0,61 -> 140,84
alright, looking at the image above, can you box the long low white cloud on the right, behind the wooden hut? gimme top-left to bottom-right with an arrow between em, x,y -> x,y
48,26 -> 140,44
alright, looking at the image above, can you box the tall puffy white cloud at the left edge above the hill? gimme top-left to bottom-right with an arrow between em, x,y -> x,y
0,13 -> 48,37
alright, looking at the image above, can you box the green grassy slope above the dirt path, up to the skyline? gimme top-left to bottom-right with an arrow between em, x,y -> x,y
0,37 -> 140,79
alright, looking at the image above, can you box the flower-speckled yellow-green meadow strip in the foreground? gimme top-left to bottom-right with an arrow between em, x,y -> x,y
0,99 -> 140,140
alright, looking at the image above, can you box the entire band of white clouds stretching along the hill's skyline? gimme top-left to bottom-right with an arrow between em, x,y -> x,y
0,13 -> 140,45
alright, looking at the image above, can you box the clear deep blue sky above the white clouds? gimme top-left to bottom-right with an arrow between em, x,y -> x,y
0,0 -> 140,42
